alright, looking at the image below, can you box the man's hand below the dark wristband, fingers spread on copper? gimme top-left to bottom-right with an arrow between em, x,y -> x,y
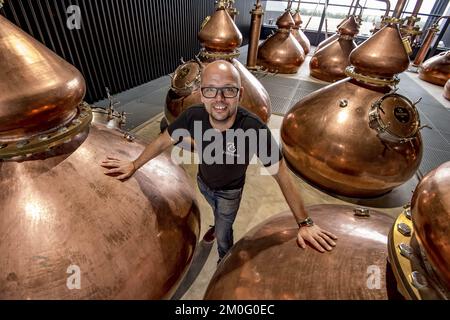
297,225 -> 337,252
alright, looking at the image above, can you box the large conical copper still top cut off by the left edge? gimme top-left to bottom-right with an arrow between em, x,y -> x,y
0,16 -> 86,144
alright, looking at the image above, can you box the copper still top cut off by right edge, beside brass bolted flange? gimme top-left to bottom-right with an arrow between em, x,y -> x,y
411,162 -> 450,290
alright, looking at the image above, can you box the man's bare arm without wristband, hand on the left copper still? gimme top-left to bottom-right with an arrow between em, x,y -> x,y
101,130 -> 175,180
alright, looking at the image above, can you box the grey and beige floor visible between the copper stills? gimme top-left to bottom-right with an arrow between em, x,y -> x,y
93,47 -> 450,299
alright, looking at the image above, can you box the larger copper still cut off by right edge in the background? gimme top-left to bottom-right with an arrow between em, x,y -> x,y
419,51 -> 450,87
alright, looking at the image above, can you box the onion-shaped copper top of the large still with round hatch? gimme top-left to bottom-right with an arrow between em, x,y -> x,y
350,24 -> 409,78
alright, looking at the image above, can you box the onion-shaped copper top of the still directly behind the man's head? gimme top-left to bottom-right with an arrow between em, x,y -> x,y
198,0 -> 242,52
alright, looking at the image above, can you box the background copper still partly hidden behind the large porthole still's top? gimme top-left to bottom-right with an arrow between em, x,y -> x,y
309,16 -> 359,82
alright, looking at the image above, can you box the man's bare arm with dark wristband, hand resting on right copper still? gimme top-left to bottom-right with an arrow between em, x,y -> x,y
268,159 -> 337,252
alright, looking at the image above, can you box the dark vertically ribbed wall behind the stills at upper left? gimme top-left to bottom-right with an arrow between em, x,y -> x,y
0,0 -> 254,102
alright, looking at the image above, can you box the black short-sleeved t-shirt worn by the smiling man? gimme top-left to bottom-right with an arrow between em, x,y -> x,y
167,105 -> 282,190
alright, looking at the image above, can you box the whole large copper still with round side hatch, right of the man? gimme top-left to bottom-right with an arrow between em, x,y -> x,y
281,24 -> 423,197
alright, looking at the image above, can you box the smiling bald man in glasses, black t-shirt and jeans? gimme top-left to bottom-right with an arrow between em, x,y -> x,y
102,60 -> 337,261
